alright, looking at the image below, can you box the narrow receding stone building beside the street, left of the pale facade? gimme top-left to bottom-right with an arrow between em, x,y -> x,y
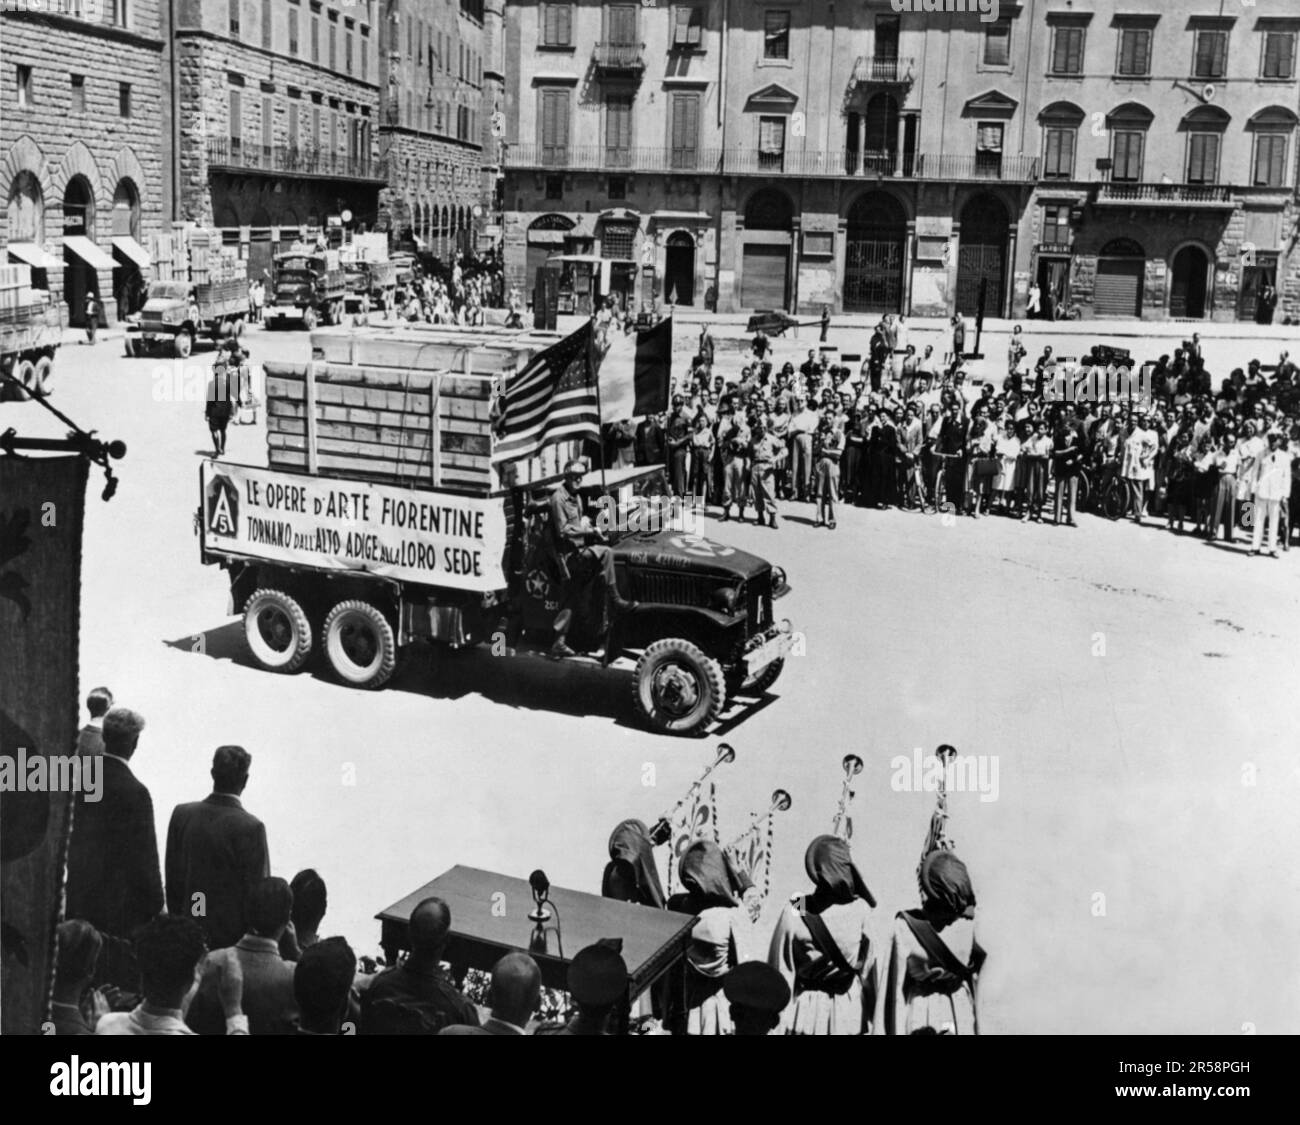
378,0 -> 503,260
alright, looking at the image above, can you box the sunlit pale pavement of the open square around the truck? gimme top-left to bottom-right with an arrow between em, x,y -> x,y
10,325 -> 1300,1034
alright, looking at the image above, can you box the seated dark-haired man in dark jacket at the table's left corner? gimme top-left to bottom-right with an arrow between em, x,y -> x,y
358,897 -> 478,1035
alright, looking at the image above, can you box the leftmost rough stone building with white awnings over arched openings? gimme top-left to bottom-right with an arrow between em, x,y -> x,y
0,0 -> 172,324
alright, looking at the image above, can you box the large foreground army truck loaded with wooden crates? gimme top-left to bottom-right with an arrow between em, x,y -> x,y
198,322 -> 793,735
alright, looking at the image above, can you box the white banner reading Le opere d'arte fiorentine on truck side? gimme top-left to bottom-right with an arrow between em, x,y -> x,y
200,460 -> 506,593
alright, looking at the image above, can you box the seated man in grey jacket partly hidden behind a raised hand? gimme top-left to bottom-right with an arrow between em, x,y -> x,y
186,877 -> 298,1035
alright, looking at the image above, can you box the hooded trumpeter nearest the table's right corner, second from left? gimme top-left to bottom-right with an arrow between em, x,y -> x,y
664,840 -> 755,1035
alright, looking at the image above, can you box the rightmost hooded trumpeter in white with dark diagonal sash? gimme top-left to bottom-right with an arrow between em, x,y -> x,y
884,851 -> 984,1035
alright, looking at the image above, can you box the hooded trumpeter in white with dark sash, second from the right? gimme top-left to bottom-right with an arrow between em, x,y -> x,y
768,836 -> 881,1035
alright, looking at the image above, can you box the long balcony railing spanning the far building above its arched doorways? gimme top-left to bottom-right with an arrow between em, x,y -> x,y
504,144 -> 1039,183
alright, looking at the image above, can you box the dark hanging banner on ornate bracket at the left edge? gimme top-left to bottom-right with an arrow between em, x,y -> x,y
0,457 -> 87,1035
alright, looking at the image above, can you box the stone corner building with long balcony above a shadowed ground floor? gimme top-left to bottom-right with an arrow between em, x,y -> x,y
174,0 -> 386,276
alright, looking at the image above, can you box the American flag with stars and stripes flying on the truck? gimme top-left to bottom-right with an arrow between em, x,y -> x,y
493,321 -> 601,462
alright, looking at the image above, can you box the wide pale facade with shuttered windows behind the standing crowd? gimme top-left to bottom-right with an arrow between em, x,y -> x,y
503,0 -> 1300,319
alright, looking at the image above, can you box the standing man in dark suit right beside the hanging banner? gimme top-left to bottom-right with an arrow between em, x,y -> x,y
65,708 -> 163,988
